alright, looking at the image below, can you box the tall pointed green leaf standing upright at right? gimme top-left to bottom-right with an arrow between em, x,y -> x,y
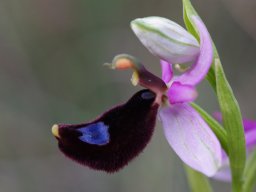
215,59 -> 246,191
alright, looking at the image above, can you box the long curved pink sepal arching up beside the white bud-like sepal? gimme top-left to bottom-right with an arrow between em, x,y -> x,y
176,16 -> 213,85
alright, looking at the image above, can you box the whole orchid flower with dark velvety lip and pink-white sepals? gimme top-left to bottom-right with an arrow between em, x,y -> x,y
52,17 -> 221,176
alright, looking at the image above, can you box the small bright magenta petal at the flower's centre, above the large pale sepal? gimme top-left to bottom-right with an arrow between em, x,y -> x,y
167,82 -> 198,104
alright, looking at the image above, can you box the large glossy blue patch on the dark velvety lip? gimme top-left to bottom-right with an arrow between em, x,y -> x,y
78,122 -> 110,145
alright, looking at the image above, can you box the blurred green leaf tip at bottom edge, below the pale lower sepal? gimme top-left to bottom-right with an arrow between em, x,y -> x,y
184,165 -> 212,192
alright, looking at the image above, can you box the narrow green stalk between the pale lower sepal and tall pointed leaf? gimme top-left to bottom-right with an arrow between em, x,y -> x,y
190,103 -> 228,154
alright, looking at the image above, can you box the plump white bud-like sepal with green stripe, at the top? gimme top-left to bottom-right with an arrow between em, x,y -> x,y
131,17 -> 200,64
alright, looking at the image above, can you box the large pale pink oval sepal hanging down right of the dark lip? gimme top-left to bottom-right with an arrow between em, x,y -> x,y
160,104 -> 221,176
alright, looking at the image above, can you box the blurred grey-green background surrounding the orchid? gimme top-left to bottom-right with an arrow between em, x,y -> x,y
0,0 -> 256,192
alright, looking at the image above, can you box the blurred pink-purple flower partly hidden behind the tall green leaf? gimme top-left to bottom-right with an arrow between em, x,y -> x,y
213,113 -> 256,182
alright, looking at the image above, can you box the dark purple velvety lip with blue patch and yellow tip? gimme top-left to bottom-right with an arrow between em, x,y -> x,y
53,90 -> 159,172
